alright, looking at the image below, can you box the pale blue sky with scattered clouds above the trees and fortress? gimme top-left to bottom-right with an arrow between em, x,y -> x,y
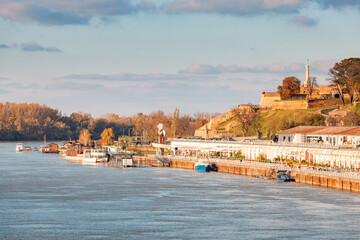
0,0 -> 360,117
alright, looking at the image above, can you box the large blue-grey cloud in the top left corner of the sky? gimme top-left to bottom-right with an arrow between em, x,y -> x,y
0,0 -> 155,25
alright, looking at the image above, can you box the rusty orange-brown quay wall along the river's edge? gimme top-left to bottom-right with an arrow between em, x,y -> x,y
134,156 -> 360,193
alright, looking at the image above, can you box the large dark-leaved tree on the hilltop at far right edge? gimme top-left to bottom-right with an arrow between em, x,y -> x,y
329,58 -> 360,105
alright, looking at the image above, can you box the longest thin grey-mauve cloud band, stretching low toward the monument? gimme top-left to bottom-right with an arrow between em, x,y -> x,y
54,59 -> 336,86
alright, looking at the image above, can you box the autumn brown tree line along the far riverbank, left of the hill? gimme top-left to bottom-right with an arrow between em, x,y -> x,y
0,102 -> 219,141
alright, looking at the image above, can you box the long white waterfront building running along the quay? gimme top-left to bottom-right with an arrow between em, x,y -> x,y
165,138 -> 360,169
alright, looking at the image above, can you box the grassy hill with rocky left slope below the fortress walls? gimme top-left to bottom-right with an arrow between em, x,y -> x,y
195,104 -> 360,139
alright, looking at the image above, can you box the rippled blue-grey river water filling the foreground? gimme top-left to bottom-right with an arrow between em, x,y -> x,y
0,142 -> 360,239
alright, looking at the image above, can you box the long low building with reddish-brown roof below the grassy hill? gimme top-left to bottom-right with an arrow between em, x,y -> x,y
279,126 -> 360,146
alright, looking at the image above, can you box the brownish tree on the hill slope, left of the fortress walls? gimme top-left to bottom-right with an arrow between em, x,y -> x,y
231,104 -> 258,137
